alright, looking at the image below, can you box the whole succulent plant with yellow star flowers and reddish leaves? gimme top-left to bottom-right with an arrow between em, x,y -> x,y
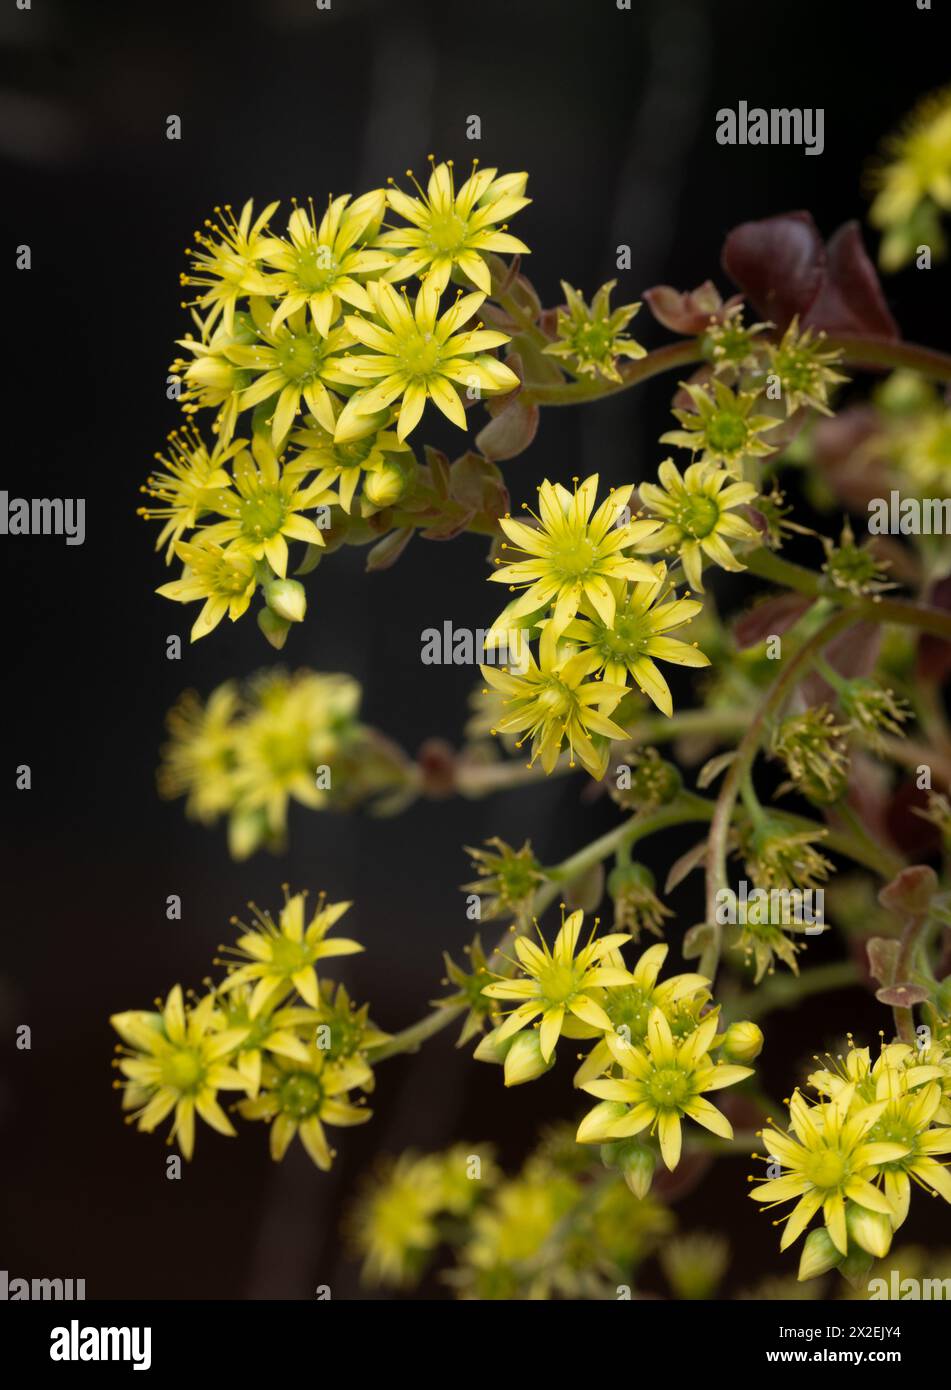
113,95 -> 951,1298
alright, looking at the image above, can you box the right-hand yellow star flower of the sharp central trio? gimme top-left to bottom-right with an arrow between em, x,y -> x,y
563,563 -> 710,716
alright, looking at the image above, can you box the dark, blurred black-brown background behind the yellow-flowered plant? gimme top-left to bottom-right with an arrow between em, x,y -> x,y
0,0 -> 950,1298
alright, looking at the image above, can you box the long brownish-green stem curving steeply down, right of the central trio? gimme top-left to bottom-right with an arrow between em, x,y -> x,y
699,612 -> 856,980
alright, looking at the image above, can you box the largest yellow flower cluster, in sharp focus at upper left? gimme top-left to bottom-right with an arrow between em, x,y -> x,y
148,161 -> 528,645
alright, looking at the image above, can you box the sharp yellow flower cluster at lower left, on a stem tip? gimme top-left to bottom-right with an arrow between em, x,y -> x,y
111,890 -> 388,1169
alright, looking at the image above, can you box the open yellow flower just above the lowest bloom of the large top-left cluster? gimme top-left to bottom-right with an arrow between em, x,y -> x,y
202,434 -> 338,578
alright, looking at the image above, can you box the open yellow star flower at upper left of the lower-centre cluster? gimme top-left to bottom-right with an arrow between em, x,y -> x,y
482,912 -> 631,1062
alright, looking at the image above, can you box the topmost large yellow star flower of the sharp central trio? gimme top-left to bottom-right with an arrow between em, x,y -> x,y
489,473 -> 660,656
